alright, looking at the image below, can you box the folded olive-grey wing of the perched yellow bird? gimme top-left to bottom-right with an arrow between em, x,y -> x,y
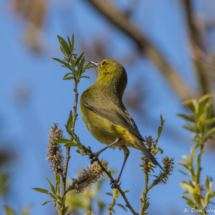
81,93 -> 145,141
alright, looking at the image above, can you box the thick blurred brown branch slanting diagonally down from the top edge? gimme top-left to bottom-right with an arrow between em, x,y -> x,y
88,0 -> 192,100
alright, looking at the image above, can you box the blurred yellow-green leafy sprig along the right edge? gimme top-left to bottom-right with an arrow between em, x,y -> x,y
178,94 -> 215,214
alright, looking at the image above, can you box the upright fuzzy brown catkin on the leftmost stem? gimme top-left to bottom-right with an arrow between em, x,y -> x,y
46,123 -> 63,173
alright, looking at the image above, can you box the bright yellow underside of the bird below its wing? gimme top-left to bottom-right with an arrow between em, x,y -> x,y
80,96 -> 141,148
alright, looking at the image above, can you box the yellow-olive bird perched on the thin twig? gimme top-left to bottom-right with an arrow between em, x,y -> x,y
80,59 -> 163,184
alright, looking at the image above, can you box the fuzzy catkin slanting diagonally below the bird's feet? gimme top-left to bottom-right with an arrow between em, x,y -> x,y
69,160 -> 108,193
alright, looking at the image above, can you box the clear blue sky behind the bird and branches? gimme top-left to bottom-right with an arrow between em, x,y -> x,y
0,0 -> 215,215
